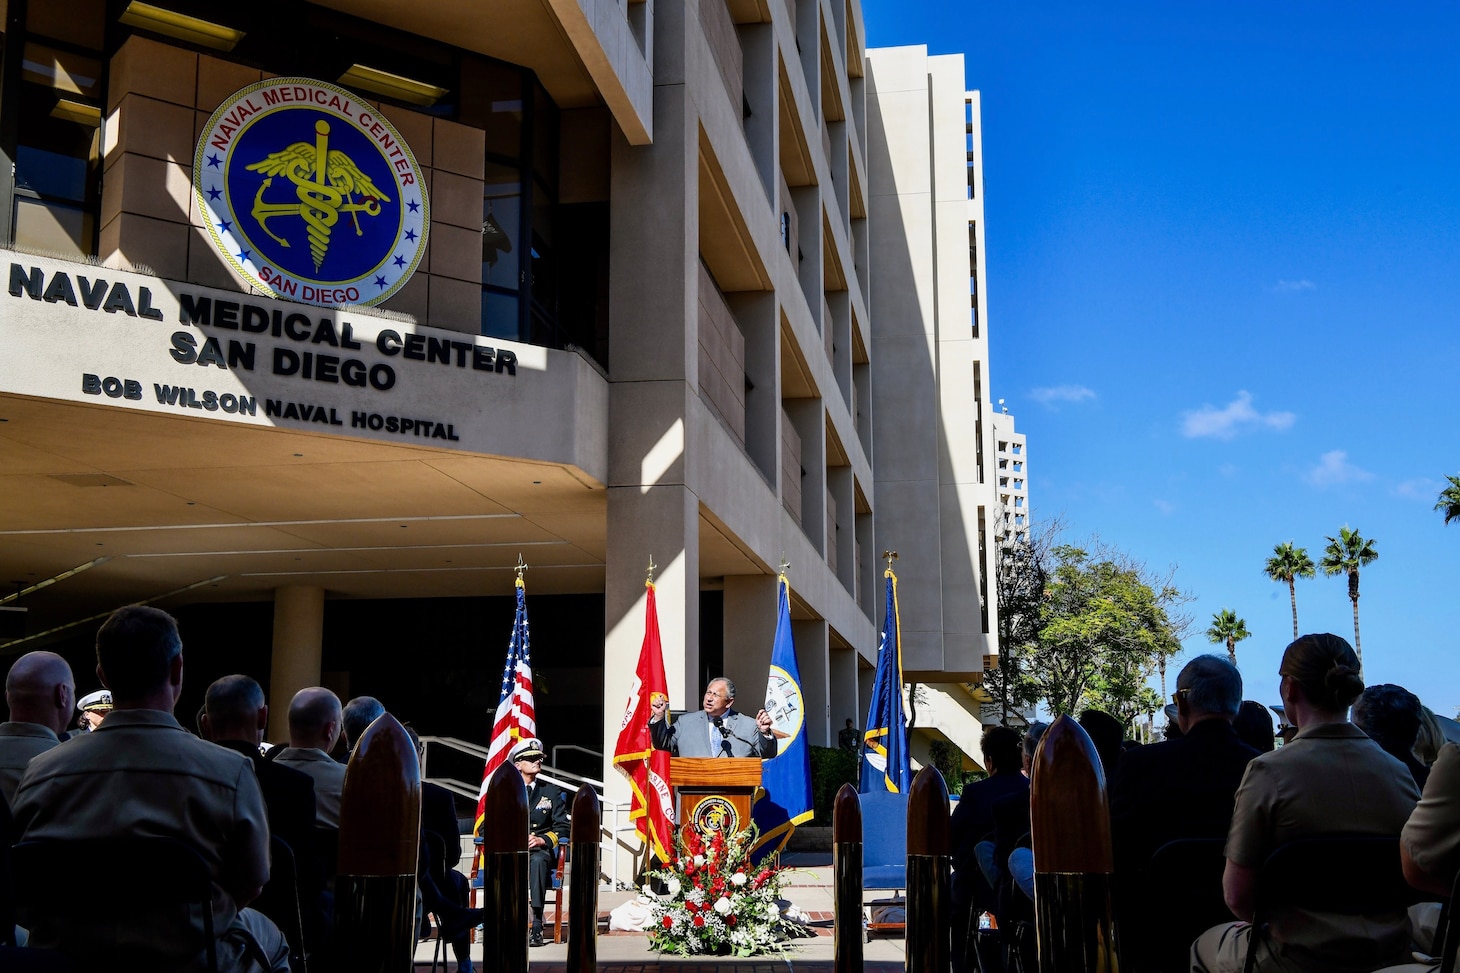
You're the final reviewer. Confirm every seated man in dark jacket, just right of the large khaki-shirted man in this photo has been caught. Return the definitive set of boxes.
[199,675,330,948]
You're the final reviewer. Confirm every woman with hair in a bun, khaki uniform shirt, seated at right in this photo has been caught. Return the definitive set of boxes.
[1191,634,1419,973]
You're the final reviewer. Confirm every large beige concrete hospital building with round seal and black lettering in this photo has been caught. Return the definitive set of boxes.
[0,0,997,799]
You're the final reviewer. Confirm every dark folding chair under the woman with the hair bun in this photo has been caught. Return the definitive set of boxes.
[1244,834,1422,973]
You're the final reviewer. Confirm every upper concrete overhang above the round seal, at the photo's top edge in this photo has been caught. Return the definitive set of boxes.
[328,0,654,145]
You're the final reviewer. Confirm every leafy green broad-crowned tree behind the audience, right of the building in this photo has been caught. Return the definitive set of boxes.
[1028,542,1190,722]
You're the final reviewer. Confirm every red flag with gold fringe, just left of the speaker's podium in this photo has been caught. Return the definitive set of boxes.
[613,572,675,862]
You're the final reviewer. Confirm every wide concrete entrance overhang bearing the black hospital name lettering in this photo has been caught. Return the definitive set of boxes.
[0,251,607,653]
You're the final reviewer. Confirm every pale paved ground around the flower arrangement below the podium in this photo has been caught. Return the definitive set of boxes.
[416,853,907,973]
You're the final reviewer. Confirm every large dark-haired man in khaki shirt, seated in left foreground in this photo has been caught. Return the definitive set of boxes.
[15,605,289,970]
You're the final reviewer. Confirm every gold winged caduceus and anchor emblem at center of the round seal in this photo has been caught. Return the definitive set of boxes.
[248,120,390,272]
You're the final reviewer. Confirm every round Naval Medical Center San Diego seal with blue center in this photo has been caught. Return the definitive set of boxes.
[193,77,431,305]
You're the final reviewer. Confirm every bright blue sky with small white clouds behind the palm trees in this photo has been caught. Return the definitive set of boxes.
[864,0,1460,716]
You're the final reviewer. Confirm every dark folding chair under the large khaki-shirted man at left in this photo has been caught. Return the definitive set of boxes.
[12,837,218,973]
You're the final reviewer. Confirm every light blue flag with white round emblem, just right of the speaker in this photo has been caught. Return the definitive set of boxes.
[750,574,816,861]
